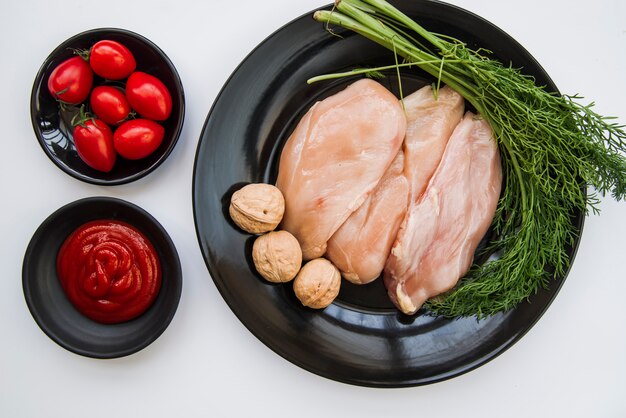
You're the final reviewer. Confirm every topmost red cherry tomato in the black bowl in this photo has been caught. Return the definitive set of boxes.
[89,40,137,80]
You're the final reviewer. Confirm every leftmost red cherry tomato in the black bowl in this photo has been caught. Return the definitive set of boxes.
[48,56,93,104]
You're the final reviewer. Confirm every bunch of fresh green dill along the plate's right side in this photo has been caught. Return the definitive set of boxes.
[314,0,626,317]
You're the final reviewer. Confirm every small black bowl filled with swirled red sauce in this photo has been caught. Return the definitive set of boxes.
[22,197,182,358]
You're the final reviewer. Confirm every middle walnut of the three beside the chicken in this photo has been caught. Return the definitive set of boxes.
[252,231,302,283]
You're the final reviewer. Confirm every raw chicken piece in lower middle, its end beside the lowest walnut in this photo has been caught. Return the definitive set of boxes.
[326,151,409,284]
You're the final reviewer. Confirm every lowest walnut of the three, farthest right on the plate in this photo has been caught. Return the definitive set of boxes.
[293,258,341,309]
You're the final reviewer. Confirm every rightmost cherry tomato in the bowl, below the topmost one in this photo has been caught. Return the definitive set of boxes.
[126,71,172,120]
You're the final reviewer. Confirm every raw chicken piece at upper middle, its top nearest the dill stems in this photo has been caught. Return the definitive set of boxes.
[404,85,464,202]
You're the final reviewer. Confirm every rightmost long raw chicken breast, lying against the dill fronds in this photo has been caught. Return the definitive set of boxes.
[384,112,502,314]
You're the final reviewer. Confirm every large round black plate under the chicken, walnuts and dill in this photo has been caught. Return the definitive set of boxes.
[193,0,583,387]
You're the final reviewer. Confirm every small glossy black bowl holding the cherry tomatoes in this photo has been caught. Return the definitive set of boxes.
[30,28,185,185]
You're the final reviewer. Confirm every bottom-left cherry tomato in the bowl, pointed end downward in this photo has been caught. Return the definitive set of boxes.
[74,119,117,172]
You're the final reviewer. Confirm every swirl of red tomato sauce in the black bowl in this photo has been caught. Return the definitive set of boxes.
[57,220,161,324]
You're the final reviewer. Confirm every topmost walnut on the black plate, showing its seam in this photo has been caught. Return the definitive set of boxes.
[228,183,285,234]
